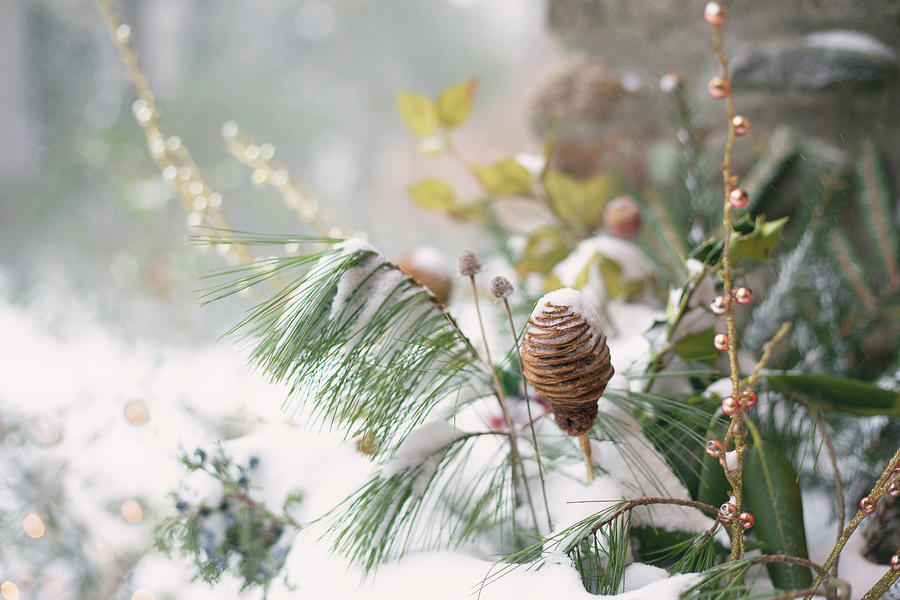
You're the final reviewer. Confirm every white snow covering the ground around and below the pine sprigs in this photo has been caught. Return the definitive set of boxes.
[0,288,708,600]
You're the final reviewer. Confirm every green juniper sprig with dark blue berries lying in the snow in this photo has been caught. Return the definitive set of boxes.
[155,446,302,591]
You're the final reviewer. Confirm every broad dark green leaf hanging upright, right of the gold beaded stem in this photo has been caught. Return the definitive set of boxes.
[744,440,812,590]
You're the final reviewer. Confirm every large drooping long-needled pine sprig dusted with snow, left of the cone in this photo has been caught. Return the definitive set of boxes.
[205,236,488,451]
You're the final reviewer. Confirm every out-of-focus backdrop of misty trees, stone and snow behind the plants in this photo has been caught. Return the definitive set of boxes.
[0,0,900,600]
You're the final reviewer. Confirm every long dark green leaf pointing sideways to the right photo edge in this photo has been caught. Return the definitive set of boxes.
[766,375,900,417]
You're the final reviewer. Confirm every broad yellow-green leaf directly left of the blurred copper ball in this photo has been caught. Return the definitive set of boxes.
[543,171,617,230]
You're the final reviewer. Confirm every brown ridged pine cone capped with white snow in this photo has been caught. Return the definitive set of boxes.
[522,288,614,436]
